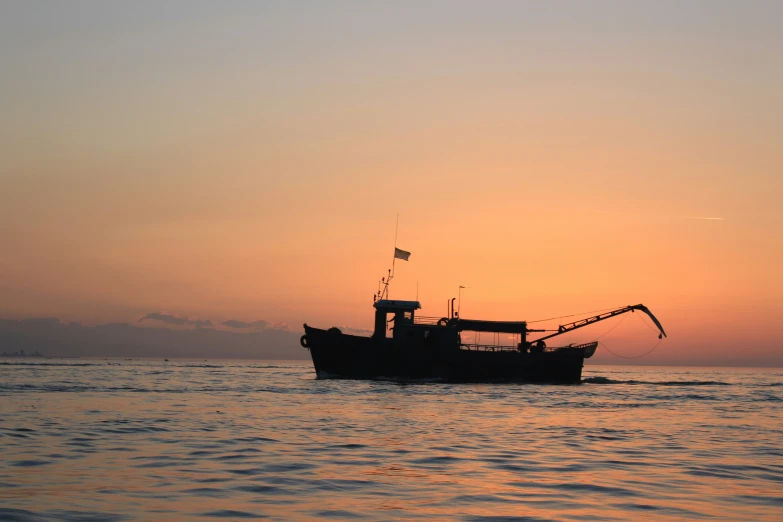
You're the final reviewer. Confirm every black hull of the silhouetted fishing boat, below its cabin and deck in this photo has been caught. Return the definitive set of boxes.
[303,325,595,384]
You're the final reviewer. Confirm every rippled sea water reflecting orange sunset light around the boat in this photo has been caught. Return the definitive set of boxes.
[0,358,783,521]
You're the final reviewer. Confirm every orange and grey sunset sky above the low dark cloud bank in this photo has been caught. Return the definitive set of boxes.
[0,1,783,365]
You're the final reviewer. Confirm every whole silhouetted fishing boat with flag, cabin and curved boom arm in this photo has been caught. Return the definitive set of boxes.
[300,247,666,384]
